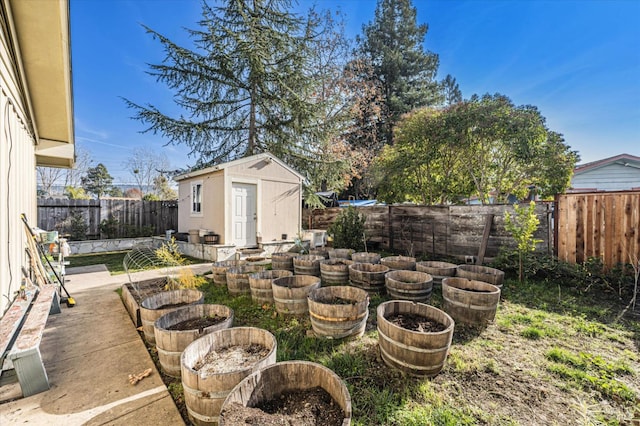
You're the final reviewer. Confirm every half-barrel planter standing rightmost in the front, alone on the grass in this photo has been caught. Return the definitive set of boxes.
[377,300,455,377]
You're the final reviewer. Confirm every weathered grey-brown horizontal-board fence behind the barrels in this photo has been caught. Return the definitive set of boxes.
[303,203,553,261]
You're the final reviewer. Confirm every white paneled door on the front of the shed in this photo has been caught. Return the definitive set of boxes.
[232,183,257,247]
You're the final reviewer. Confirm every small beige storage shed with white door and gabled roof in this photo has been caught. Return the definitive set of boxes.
[174,153,303,248]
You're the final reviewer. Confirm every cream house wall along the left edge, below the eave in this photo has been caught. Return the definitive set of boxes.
[0,21,36,316]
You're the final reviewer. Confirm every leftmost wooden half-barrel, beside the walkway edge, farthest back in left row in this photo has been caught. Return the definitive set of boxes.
[140,290,204,345]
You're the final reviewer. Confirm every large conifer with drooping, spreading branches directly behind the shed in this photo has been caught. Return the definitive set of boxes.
[126,0,315,166]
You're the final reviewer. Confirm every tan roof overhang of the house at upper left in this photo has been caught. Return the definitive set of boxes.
[7,0,75,168]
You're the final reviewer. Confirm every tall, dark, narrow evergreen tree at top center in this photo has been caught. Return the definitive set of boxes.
[358,0,442,143]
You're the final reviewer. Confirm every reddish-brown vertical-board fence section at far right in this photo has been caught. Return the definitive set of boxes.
[556,191,640,268]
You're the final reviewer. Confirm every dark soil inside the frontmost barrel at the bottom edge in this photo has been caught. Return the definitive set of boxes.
[224,387,344,426]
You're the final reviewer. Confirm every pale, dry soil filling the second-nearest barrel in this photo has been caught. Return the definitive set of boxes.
[193,343,269,375]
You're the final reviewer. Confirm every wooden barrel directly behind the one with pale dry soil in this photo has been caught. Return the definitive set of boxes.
[154,304,233,377]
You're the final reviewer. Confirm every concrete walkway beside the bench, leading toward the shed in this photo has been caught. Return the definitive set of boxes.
[0,264,211,426]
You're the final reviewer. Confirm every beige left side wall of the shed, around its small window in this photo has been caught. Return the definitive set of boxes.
[177,171,225,240]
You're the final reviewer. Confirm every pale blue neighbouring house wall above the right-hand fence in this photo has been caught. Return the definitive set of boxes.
[571,163,640,191]
